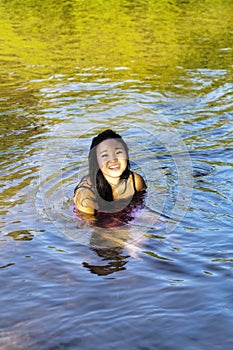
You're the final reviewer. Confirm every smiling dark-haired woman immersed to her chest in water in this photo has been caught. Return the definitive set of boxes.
[73,130,146,215]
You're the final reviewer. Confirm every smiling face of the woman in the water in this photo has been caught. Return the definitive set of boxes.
[96,139,127,182]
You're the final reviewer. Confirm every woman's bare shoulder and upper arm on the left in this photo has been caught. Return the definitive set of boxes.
[73,179,97,214]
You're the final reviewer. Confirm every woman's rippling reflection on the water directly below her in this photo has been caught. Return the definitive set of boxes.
[79,193,145,276]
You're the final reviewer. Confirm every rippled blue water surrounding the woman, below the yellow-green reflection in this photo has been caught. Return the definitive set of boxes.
[1,72,233,349]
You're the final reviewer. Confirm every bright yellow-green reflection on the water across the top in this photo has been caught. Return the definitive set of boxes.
[0,0,233,86]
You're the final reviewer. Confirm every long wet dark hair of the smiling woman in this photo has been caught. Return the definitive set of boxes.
[88,129,130,202]
